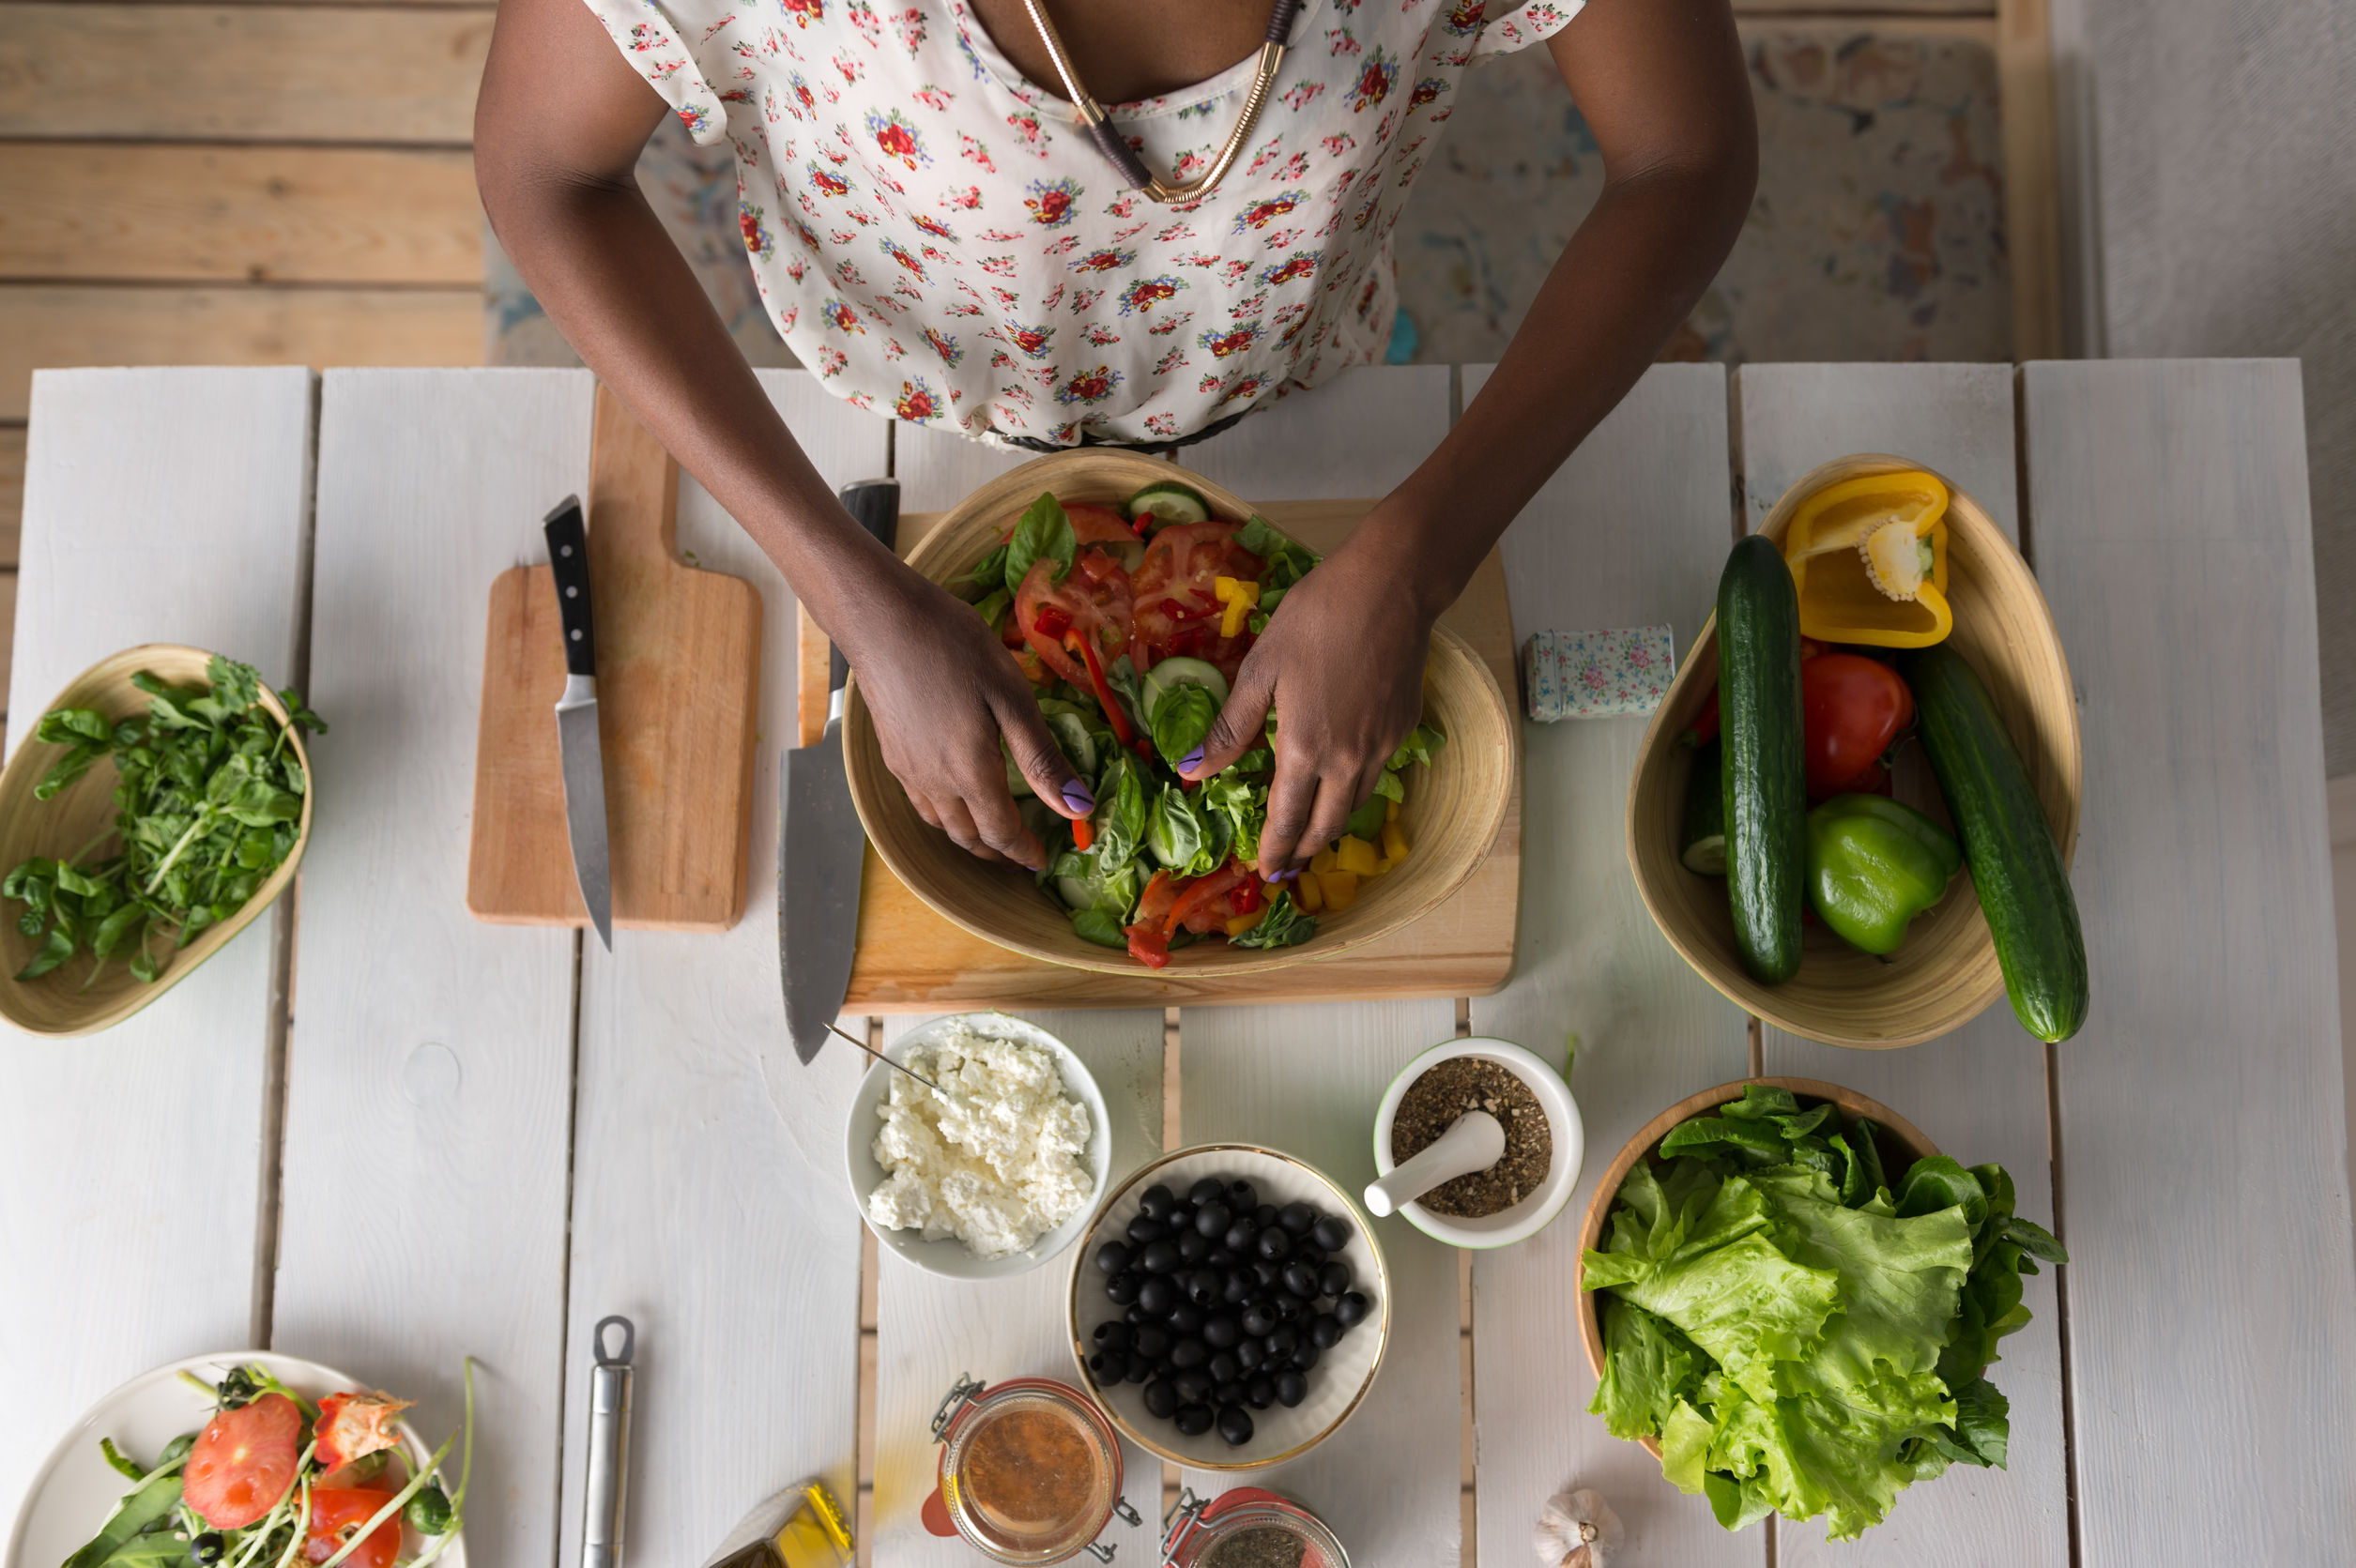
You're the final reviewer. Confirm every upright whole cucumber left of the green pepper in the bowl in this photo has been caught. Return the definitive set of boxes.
[1718,535,1807,984]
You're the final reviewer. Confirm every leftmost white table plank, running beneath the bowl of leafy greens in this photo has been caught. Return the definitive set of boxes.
[0,370,311,1532]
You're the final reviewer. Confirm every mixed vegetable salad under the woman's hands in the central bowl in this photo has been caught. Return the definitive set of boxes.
[964,482,1442,970]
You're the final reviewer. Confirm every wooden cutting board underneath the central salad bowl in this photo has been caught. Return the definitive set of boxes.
[796,499,1522,1012]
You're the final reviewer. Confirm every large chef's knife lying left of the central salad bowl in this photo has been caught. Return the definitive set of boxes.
[777,480,900,1062]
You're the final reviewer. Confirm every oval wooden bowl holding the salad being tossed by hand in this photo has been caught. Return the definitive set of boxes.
[844,449,1517,980]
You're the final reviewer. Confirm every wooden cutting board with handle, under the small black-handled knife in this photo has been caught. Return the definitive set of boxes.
[467,386,768,930]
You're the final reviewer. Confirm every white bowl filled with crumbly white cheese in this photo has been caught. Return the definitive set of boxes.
[844,1012,1112,1278]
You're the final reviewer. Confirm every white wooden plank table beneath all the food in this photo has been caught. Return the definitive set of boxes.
[0,360,2356,1568]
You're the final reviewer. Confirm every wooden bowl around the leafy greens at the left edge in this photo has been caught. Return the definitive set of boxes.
[0,643,318,1036]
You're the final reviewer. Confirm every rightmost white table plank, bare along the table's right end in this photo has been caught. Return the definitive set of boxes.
[2022,360,2356,1563]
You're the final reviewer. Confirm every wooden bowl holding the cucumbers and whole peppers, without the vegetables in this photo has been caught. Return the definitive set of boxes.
[1628,454,2083,1050]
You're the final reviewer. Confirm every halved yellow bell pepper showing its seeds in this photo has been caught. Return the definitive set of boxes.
[1783,471,1955,647]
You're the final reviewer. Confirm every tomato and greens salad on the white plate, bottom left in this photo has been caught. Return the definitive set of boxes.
[66,1363,474,1568]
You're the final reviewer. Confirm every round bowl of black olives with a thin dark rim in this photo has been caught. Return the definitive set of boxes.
[1070,1144,1390,1469]
